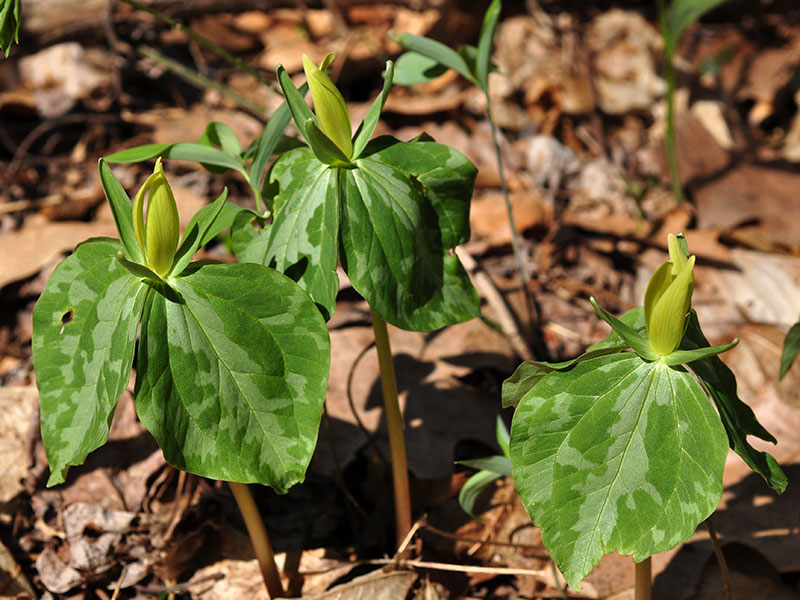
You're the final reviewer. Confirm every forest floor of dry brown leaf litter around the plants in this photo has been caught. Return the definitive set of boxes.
[0,0,800,600]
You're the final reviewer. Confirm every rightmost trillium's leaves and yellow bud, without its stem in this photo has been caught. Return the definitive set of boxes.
[503,235,787,587]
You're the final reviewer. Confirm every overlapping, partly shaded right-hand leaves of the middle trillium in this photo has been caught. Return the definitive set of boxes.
[340,138,480,331]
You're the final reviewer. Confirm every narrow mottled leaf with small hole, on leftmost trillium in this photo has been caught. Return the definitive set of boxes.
[33,239,148,485]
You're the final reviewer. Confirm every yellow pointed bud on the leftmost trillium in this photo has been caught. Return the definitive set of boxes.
[133,158,180,277]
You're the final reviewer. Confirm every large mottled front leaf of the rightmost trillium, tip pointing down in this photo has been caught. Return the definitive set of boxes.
[511,353,727,587]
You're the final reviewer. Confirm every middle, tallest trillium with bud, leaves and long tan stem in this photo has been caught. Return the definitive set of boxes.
[108,54,480,539]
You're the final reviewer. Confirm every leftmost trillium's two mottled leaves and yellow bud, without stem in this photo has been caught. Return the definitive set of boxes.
[33,160,330,492]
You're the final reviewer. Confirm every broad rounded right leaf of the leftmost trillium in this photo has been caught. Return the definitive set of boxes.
[136,264,330,493]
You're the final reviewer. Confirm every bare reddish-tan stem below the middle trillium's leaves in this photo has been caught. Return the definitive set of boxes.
[372,311,411,544]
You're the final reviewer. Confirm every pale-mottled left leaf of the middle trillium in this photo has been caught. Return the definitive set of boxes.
[260,147,339,319]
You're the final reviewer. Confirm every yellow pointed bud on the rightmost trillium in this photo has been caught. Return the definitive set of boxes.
[644,234,695,356]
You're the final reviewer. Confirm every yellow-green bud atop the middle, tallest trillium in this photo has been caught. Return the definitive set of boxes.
[303,52,353,159]
